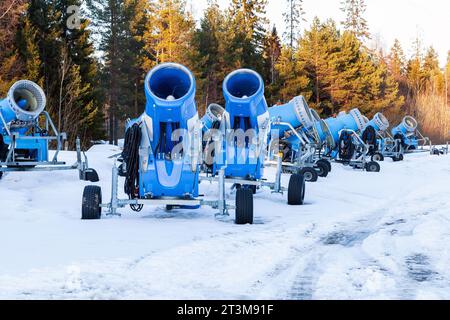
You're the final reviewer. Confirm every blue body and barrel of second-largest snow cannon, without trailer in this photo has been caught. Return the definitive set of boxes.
[223,69,270,180]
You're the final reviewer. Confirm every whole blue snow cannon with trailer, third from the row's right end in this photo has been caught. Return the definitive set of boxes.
[319,109,380,172]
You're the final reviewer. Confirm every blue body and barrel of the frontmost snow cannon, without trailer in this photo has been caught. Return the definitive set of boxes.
[135,63,201,198]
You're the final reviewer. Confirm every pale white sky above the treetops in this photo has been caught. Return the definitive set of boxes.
[190,0,450,66]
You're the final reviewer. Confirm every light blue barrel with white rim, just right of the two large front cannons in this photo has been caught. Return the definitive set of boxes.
[269,96,314,138]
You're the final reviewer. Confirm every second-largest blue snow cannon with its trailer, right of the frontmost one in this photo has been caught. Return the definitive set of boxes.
[201,69,305,214]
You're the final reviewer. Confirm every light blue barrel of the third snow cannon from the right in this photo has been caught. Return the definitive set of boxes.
[320,109,367,149]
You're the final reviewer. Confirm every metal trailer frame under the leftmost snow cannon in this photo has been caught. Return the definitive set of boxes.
[0,111,98,182]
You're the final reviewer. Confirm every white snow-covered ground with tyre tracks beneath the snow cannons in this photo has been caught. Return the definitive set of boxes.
[0,145,450,299]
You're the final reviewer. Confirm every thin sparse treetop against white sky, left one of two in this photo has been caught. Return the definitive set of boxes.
[283,0,306,48]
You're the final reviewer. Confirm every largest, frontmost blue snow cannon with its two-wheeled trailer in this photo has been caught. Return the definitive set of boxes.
[82,63,248,223]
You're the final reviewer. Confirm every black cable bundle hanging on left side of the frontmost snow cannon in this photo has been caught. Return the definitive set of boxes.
[122,123,144,212]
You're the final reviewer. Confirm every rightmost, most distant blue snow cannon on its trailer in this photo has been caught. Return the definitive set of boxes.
[391,116,431,153]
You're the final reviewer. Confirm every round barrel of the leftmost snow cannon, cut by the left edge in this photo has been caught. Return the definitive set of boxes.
[0,80,46,132]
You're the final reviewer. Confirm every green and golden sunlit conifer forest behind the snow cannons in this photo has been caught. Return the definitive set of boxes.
[0,0,450,147]
